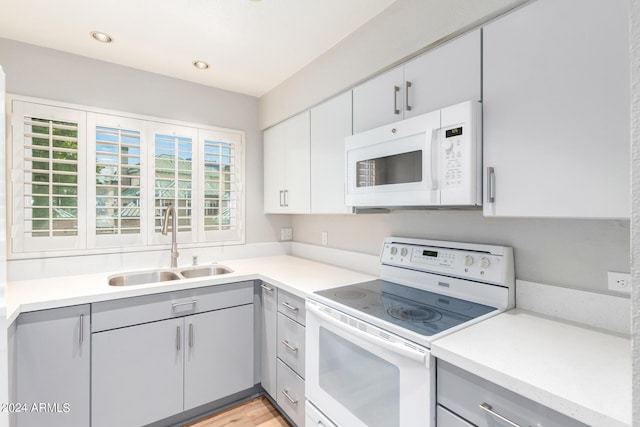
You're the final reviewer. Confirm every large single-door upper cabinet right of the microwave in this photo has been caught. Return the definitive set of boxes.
[483,0,630,218]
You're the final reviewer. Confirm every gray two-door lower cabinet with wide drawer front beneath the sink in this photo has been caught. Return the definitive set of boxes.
[91,282,254,427]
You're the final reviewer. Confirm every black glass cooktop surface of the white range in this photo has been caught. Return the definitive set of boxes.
[316,280,497,336]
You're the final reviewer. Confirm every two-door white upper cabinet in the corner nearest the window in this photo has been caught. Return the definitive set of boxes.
[264,111,311,214]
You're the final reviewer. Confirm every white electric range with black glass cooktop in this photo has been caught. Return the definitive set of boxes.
[305,237,515,427]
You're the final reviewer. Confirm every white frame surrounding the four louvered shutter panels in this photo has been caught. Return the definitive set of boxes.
[6,94,246,259]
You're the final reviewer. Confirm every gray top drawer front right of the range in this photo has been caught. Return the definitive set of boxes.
[436,360,587,427]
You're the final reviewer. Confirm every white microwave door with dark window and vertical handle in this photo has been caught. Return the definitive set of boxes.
[345,111,440,207]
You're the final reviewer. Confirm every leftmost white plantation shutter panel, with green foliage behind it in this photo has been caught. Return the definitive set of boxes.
[11,101,86,252]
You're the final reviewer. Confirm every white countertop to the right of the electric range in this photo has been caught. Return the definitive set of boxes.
[431,309,631,427]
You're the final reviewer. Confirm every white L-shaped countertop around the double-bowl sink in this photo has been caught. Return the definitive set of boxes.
[7,255,374,324]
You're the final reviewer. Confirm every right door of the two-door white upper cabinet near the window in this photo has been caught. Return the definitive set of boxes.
[283,111,311,213]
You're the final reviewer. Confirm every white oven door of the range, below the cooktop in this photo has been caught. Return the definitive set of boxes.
[306,300,435,427]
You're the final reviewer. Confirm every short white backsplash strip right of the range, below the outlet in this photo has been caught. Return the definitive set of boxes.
[516,280,631,335]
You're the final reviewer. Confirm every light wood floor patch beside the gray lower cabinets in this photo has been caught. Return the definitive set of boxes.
[183,396,291,427]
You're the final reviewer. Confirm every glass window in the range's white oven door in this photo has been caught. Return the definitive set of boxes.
[318,327,400,427]
